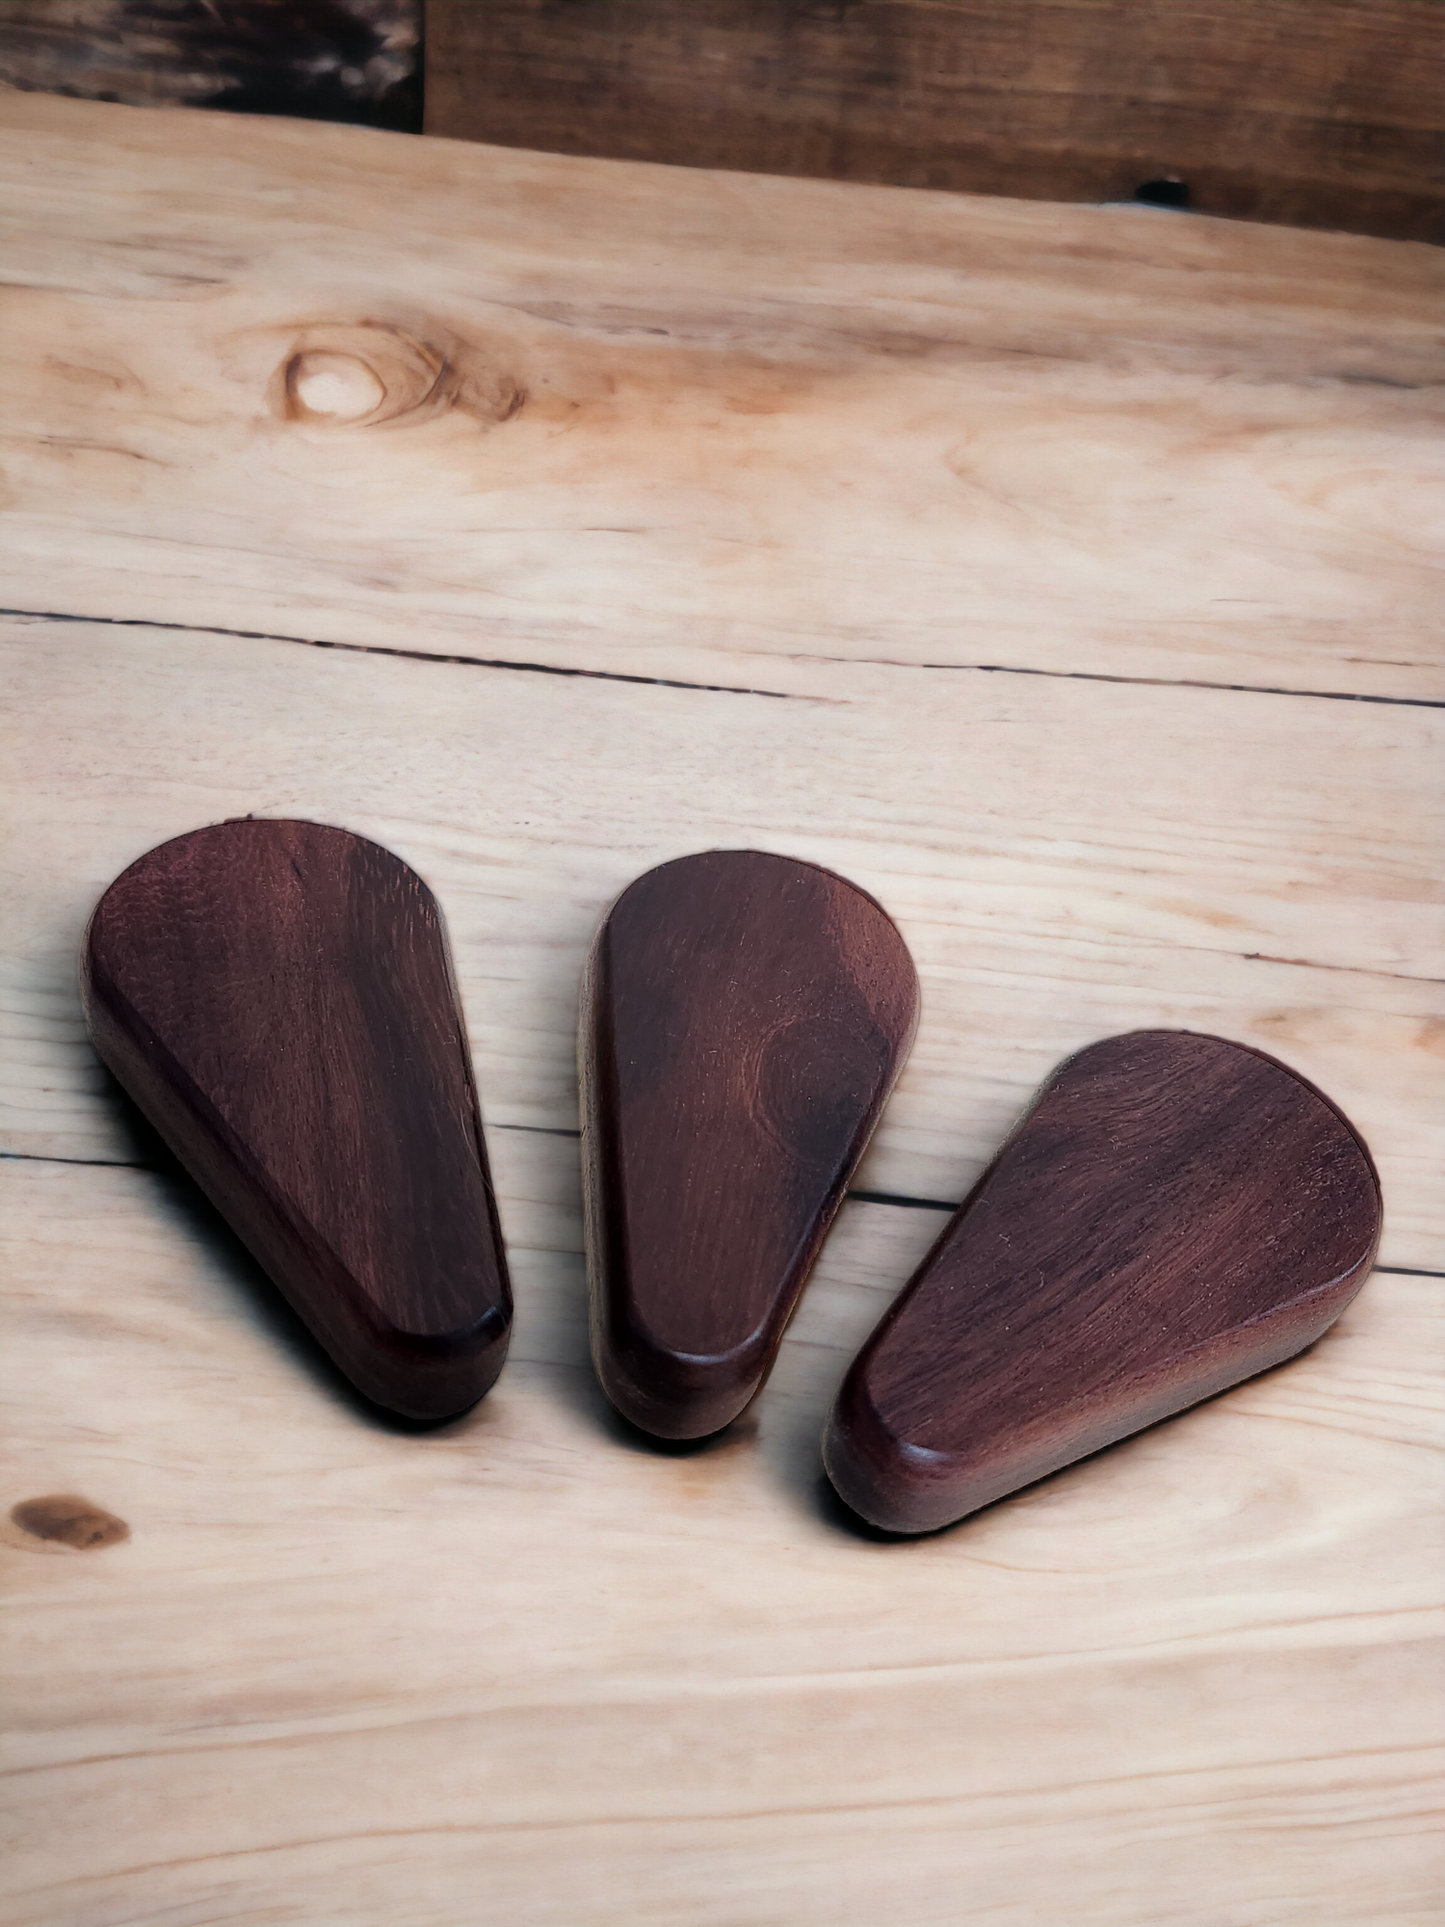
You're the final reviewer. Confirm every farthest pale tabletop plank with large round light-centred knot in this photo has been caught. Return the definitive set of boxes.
[0,94,1445,700]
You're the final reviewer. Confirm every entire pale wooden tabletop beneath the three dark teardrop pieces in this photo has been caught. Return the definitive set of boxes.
[0,98,1445,1927]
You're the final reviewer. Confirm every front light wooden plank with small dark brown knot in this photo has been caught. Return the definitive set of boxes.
[0,1133,1445,1927]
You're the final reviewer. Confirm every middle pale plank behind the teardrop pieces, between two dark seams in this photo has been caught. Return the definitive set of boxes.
[0,620,1445,1270]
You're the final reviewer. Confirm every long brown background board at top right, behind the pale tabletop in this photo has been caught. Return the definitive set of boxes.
[426,0,1445,241]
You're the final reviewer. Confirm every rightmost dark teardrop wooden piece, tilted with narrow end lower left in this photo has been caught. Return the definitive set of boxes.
[823,1031,1379,1532]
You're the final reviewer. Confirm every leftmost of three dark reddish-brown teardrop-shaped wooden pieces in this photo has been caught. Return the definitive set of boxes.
[81,817,512,1420]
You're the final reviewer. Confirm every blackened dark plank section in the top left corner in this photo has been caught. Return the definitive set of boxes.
[0,0,422,133]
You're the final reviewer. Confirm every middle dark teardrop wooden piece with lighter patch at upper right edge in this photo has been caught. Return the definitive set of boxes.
[578,850,917,1439]
